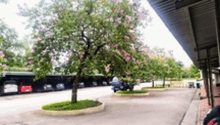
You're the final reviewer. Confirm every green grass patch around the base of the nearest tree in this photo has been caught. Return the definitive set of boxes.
[42,100,101,111]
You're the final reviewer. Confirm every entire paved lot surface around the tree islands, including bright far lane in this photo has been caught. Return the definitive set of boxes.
[0,83,196,125]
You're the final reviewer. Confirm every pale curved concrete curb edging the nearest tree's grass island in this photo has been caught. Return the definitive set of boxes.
[41,103,105,116]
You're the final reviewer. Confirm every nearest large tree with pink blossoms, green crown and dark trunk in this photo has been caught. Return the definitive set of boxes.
[19,0,148,103]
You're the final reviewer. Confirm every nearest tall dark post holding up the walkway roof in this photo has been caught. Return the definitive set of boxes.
[206,49,214,108]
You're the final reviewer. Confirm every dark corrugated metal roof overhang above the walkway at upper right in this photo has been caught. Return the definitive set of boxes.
[149,0,219,68]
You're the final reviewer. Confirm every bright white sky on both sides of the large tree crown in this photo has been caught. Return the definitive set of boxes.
[0,0,192,67]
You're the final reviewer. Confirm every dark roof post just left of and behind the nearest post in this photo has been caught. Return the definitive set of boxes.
[202,65,211,105]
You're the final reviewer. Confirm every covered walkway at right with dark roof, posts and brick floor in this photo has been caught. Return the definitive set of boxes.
[149,0,220,121]
